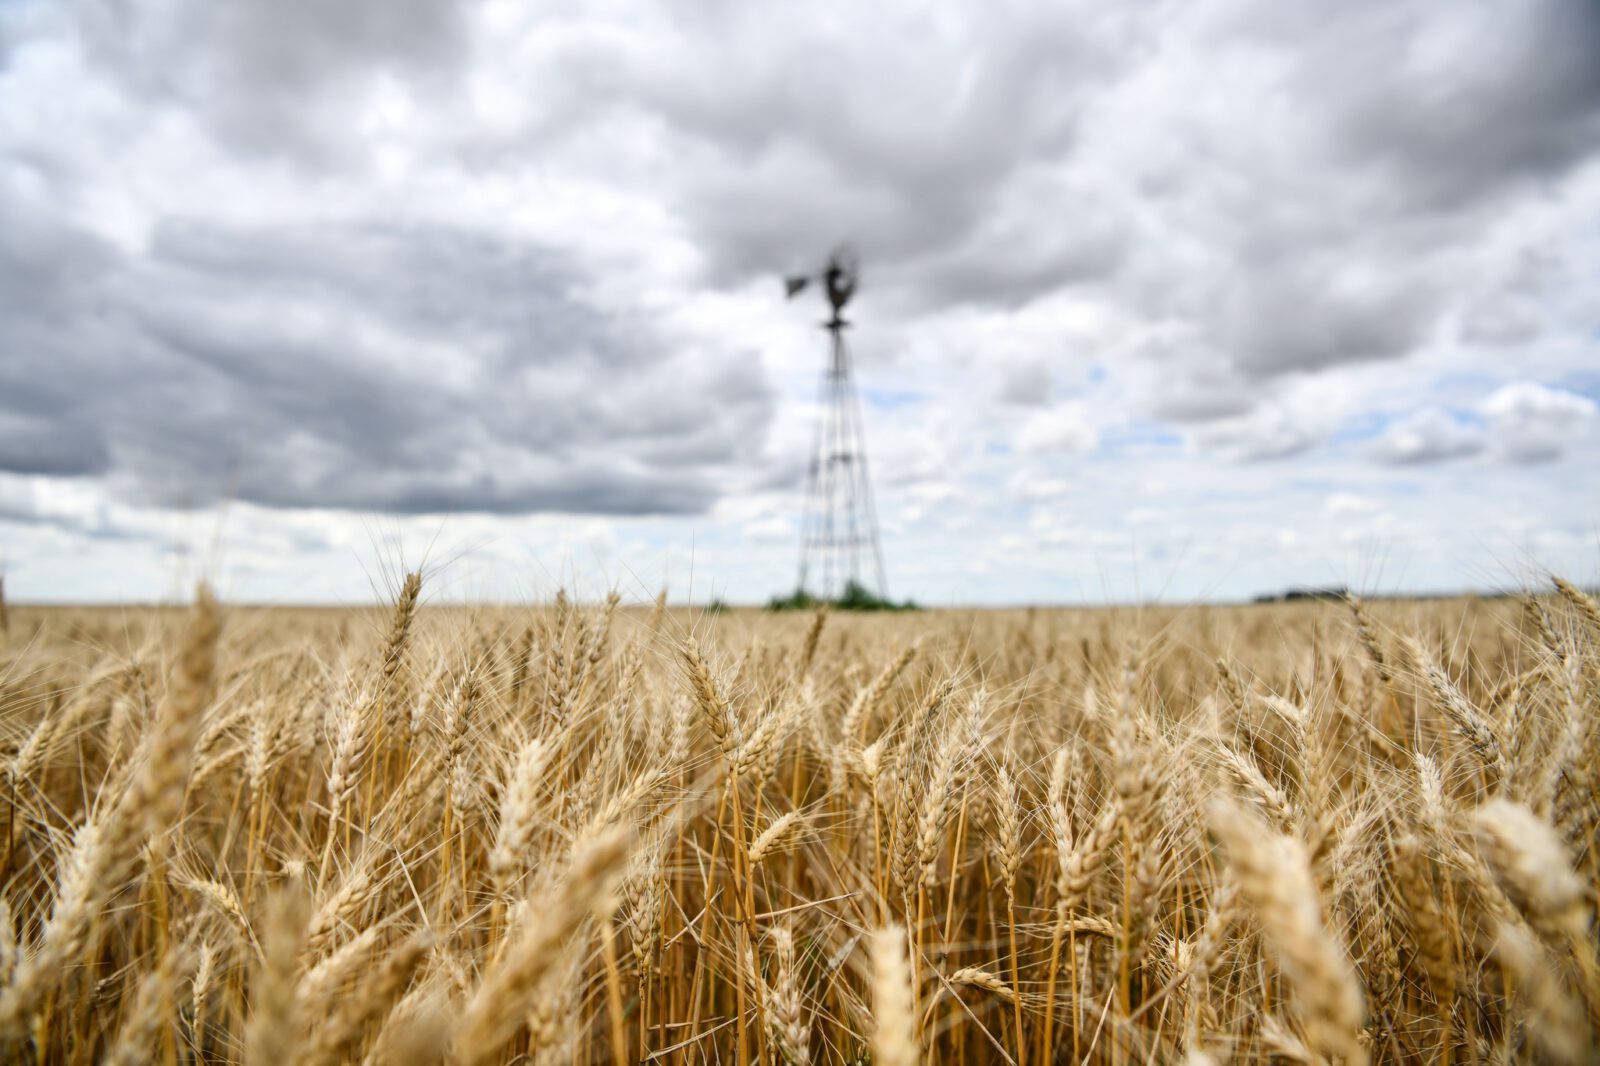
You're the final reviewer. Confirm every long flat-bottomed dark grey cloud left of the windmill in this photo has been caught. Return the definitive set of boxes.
[0,198,771,514]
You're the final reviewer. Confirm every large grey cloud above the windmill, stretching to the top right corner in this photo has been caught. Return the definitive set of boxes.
[540,0,1600,358]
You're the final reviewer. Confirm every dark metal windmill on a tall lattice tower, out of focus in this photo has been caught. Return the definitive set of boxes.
[787,248,888,600]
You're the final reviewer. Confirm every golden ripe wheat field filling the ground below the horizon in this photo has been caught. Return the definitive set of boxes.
[0,578,1600,1066]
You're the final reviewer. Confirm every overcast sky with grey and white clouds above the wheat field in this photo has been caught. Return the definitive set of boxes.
[0,0,1600,605]
